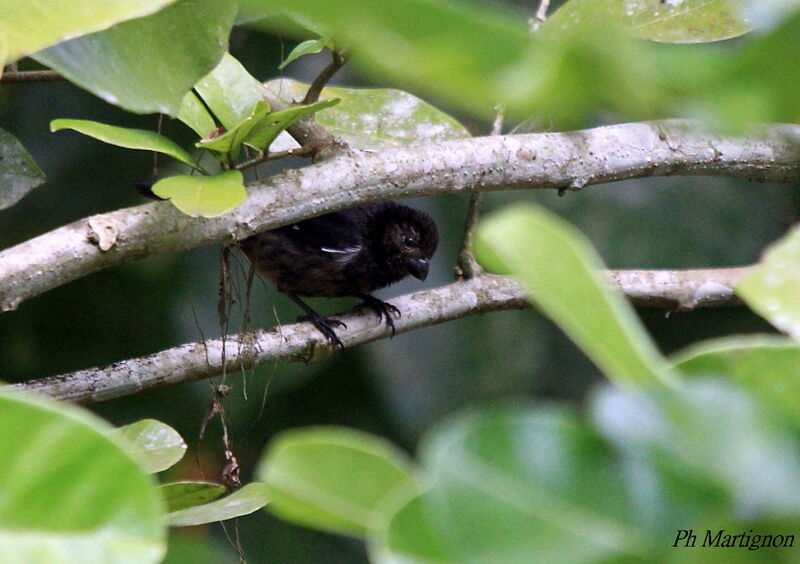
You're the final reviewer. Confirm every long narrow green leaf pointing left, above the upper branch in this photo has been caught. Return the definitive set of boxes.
[50,119,198,169]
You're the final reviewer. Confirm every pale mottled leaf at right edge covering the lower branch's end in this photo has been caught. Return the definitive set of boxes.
[736,227,800,340]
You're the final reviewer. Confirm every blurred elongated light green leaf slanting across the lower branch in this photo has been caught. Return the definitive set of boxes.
[475,205,671,386]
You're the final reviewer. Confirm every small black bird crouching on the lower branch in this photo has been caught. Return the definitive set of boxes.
[240,198,439,348]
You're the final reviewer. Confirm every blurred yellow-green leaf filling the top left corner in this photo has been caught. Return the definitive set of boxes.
[0,0,175,67]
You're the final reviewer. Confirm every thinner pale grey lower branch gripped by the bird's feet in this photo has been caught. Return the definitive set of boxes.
[11,267,748,403]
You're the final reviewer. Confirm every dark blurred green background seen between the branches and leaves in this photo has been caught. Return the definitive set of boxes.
[0,2,800,563]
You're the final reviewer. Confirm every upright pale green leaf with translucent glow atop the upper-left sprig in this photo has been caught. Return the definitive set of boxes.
[195,53,269,131]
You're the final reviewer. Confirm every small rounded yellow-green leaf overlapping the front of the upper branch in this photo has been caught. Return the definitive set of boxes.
[152,170,247,217]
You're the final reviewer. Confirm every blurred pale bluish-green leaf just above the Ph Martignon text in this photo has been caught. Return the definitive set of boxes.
[593,379,800,528]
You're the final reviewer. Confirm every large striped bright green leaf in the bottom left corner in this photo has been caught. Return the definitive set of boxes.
[0,390,166,564]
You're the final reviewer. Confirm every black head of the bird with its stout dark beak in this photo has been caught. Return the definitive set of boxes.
[381,202,439,280]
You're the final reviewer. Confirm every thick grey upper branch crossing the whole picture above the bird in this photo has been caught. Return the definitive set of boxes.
[0,121,800,310]
